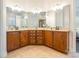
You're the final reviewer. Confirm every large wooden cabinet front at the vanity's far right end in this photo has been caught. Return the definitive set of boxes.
[54,32,68,53]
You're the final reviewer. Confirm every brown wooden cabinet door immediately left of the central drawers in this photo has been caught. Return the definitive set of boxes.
[20,31,29,46]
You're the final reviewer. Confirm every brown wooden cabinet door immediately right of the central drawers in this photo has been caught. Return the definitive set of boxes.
[45,31,54,47]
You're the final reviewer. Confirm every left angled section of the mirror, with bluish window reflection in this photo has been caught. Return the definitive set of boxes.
[6,7,28,29]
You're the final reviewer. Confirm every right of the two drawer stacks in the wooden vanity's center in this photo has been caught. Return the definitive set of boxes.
[36,30,44,44]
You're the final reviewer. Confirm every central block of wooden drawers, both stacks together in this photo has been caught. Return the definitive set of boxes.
[29,30,44,45]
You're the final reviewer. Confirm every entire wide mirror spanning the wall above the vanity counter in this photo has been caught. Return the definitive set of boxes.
[6,5,70,29]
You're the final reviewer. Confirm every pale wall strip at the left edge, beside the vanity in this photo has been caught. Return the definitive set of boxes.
[0,0,7,58]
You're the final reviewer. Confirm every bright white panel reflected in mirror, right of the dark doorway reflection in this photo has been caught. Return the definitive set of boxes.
[46,11,55,28]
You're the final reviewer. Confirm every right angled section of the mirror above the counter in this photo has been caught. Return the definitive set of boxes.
[46,5,70,29]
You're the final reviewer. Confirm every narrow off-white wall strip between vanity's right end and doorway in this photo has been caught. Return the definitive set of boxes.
[69,0,76,56]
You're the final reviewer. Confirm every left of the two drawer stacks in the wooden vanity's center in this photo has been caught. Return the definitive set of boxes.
[28,30,36,45]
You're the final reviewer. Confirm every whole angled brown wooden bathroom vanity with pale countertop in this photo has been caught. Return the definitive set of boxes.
[7,28,69,53]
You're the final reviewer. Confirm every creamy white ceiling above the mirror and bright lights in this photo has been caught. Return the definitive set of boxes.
[5,0,71,11]
